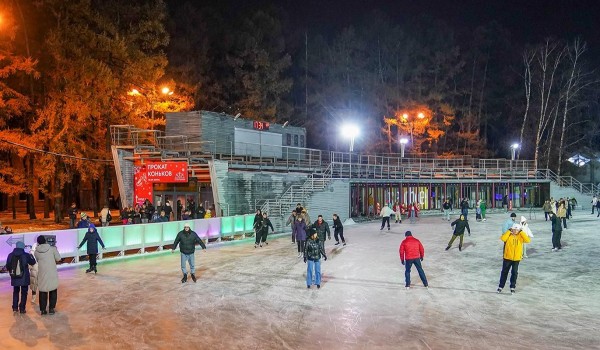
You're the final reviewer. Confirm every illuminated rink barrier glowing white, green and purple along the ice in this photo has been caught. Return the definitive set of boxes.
[0,214,255,266]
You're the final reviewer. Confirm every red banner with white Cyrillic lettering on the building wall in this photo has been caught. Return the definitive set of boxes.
[133,162,188,204]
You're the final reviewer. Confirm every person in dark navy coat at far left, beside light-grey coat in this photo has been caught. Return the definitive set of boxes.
[6,241,36,314]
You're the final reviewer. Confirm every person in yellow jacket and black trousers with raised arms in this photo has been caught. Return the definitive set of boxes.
[498,224,531,294]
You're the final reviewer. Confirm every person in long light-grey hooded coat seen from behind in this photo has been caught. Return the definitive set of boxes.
[35,235,61,315]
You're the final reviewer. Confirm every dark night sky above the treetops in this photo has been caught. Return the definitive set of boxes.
[210,0,600,52]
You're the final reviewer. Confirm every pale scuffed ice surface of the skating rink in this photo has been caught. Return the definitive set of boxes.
[0,210,600,350]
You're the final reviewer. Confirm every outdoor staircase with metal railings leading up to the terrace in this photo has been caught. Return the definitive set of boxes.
[260,164,332,221]
